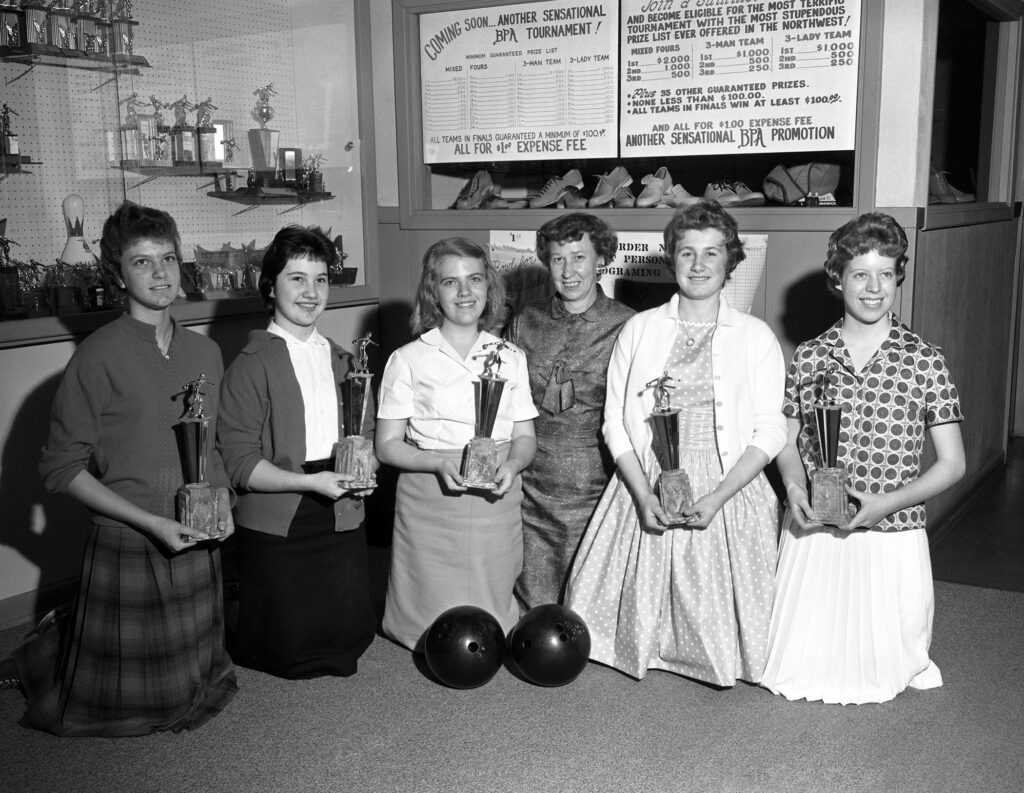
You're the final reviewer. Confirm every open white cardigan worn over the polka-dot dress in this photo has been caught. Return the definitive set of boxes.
[602,294,786,473]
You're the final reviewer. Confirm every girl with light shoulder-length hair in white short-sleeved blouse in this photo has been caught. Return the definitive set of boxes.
[377,237,537,652]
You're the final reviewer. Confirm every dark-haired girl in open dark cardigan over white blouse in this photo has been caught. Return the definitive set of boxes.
[218,225,377,678]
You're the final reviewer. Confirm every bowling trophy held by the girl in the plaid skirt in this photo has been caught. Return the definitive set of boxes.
[174,374,220,540]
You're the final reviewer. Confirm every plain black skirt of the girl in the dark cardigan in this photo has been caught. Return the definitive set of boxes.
[231,495,377,679]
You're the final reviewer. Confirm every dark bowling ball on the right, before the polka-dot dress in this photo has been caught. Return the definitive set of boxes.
[509,603,590,685]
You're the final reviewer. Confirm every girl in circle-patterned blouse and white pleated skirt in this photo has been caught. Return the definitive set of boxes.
[762,213,965,705]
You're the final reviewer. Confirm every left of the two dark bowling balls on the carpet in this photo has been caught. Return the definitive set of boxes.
[423,606,505,688]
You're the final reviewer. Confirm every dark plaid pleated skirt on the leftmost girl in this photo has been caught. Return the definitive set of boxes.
[15,525,238,737]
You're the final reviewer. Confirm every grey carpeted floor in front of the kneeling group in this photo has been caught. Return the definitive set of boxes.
[0,583,1024,793]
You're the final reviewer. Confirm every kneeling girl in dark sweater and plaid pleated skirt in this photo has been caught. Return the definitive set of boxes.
[15,204,237,737]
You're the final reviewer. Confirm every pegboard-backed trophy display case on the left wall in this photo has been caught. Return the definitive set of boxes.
[0,0,377,347]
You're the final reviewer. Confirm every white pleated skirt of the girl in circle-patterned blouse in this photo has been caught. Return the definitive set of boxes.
[761,514,942,705]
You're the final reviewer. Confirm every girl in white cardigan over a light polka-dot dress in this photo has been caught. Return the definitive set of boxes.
[567,201,785,686]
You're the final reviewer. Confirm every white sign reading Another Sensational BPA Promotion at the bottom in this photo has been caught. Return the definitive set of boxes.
[620,0,860,157]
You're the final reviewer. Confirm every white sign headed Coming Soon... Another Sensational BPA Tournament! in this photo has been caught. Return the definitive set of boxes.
[420,0,620,164]
